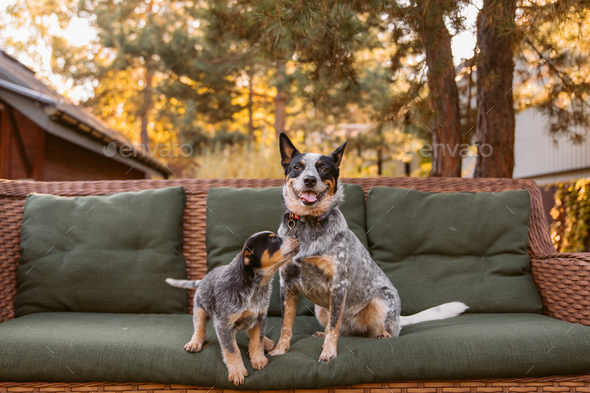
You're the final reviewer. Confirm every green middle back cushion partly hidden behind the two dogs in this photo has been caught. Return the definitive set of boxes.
[206,184,368,315]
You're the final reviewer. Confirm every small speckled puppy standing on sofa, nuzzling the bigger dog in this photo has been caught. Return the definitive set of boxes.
[166,232,299,386]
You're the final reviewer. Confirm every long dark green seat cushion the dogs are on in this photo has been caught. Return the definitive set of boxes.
[0,313,590,390]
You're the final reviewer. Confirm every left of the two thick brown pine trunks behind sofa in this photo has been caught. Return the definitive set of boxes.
[419,13,462,177]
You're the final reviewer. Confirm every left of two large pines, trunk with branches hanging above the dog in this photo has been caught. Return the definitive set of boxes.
[256,0,462,176]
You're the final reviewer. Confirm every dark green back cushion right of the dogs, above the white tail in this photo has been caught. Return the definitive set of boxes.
[367,187,543,315]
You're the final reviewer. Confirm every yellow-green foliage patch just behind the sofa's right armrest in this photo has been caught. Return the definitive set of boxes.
[551,179,590,252]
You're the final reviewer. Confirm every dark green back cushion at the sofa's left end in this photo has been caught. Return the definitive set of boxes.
[15,187,187,316]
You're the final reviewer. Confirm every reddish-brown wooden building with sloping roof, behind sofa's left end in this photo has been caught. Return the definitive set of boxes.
[0,50,170,181]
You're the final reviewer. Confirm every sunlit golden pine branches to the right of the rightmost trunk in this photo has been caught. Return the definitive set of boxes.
[513,0,590,143]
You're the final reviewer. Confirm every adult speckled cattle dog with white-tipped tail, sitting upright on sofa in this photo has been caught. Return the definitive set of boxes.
[269,133,467,362]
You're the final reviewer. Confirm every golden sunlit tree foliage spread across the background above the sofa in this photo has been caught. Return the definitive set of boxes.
[0,0,590,175]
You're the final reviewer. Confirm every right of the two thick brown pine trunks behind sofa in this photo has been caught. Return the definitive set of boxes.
[475,0,516,177]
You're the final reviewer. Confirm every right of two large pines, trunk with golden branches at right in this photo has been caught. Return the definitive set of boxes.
[475,0,590,177]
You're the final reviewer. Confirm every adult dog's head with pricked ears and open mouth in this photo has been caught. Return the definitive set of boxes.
[279,133,346,216]
